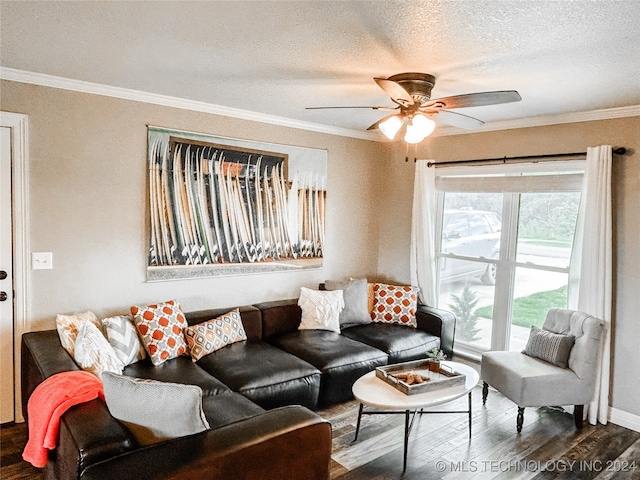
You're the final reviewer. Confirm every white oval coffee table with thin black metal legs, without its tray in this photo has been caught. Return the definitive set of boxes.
[353,361,480,471]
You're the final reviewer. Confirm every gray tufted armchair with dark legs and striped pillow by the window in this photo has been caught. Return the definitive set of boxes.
[480,309,604,433]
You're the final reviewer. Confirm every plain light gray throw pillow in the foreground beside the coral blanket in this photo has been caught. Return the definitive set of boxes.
[102,372,209,445]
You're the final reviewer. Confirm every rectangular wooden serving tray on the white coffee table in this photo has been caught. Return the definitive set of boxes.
[376,360,465,395]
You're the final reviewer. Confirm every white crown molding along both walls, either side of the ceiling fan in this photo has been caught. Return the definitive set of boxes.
[0,67,640,142]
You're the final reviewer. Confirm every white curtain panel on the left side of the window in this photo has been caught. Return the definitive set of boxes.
[410,160,436,306]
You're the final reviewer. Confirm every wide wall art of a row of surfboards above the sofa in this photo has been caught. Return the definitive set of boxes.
[147,126,327,281]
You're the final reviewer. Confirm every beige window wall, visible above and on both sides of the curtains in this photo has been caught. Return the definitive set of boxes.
[378,117,640,415]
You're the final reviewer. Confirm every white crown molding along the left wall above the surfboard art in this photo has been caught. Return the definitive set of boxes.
[0,67,380,141]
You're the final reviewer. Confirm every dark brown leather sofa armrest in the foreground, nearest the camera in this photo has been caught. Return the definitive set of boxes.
[80,406,331,480]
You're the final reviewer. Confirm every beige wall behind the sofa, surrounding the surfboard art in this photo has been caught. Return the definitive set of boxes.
[0,81,388,330]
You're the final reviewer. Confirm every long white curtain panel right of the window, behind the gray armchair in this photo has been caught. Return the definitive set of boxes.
[569,145,613,425]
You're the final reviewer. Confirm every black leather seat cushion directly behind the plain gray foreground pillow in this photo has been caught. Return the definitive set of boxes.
[122,357,230,396]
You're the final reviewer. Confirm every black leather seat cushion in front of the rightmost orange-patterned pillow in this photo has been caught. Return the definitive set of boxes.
[342,322,440,363]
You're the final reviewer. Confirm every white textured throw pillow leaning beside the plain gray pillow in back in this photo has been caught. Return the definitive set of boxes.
[298,287,344,333]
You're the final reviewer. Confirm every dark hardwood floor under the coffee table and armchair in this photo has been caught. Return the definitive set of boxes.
[0,387,640,480]
